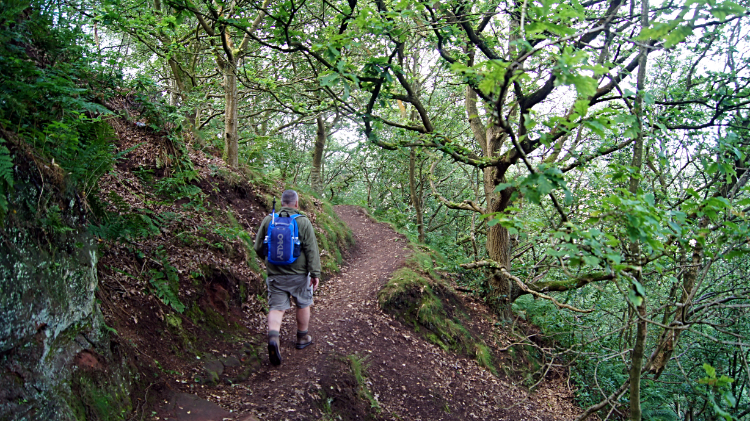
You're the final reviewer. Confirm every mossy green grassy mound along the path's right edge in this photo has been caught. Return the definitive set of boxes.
[378,246,497,374]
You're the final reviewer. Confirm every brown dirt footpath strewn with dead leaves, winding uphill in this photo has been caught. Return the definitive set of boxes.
[154,206,570,421]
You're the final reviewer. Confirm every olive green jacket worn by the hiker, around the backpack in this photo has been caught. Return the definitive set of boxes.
[253,206,320,278]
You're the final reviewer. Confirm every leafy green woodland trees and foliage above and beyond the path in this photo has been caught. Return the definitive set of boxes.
[0,0,750,420]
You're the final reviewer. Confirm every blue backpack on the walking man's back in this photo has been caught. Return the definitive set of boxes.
[263,201,302,266]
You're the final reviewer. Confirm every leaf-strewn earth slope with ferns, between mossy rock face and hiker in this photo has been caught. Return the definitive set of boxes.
[86,97,351,419]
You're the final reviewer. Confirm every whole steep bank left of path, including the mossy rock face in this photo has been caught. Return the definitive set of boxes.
[0,91,351,420]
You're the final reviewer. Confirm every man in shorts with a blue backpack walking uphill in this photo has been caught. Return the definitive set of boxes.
[254,190,320,365]
